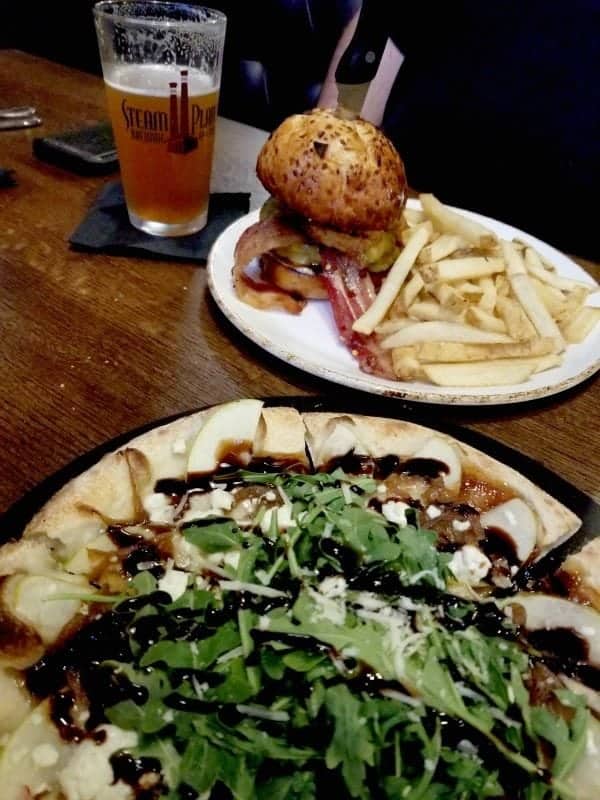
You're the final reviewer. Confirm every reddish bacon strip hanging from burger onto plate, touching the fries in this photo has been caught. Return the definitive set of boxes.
[321,249,395,380]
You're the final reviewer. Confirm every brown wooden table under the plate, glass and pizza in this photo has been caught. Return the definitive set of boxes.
[0,50,600,510]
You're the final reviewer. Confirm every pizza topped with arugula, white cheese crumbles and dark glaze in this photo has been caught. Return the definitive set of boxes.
[0,399,600,800]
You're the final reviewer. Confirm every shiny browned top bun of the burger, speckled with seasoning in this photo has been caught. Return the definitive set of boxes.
[256,108,406,233]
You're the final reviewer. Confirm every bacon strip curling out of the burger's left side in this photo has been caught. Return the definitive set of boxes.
[232,217,306,314]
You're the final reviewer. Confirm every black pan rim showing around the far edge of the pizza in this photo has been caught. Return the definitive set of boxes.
[0,396,600,582]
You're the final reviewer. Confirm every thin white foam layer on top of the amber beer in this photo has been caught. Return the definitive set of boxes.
[104,64,219,97]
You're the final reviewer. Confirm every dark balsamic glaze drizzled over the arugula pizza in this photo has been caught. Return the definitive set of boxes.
[19,451,584,800]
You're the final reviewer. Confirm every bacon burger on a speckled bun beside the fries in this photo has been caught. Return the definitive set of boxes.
[233,109,407,372]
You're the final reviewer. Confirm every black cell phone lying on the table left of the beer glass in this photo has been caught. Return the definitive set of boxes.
[33,122,119,175]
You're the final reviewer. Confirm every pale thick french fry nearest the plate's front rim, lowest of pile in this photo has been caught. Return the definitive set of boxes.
[421,359,535,386]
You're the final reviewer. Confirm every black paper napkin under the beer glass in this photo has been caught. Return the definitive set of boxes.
[69,182,250,261]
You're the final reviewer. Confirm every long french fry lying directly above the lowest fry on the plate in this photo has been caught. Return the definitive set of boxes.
[396,339,560,364]
